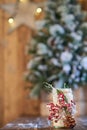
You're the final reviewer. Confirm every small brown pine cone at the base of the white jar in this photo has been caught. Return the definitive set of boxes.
[64,115,76,128]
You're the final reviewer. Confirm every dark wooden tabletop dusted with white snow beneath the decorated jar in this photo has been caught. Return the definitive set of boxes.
[0,117,87,130]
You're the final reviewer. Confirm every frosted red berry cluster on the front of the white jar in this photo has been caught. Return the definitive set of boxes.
[47,93,75,122]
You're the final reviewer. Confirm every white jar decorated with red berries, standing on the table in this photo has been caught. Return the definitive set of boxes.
[52,88,76,128]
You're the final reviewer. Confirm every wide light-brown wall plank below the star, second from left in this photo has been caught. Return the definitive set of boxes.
[4,0,23,123]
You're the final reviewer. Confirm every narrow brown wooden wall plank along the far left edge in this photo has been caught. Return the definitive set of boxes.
[0,0,5,126]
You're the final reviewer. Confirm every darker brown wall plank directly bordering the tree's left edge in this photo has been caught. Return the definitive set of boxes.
[17,26,40,115]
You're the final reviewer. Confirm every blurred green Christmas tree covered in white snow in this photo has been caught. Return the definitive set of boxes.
[26,0,87,95]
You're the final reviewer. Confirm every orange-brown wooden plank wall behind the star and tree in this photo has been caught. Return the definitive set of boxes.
[0,0,87,126]
